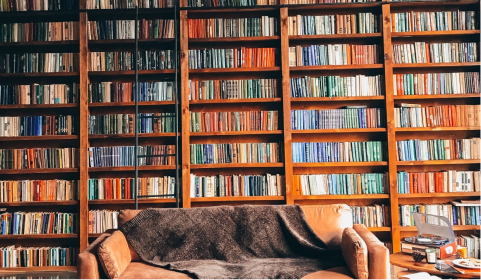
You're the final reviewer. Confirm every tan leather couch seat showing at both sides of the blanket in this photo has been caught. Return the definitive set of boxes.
[119,262,354,279]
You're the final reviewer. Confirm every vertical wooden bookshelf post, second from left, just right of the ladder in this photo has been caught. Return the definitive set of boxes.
[180,10,190,208]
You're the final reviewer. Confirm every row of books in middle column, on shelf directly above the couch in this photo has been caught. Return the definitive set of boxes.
[190,173,285,197]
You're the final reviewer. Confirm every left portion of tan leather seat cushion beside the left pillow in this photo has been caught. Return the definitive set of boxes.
[120,262,193,279]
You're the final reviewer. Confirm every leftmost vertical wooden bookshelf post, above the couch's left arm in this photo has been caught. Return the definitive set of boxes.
[78,8,89,251]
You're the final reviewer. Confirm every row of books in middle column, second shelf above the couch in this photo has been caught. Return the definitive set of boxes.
[190,143,282,164]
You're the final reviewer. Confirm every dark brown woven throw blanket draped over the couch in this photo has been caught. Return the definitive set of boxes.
[121,205,344,279]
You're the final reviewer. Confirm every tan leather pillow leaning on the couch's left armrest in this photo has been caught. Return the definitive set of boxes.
[98,230,131,279]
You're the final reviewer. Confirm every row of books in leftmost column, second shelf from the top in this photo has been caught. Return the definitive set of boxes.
[0,21,79,42]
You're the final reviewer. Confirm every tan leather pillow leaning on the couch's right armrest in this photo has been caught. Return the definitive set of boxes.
[341,228,369,279]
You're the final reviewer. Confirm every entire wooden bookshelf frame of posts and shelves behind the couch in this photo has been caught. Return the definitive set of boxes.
[0,0,481,266]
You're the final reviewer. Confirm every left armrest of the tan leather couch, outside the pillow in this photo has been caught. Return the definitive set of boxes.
[77,233,110,279]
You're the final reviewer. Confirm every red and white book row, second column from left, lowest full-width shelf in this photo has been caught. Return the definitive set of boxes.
[88,176,176,200]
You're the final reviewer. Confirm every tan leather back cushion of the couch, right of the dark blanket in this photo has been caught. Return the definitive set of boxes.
[301,204,352,249]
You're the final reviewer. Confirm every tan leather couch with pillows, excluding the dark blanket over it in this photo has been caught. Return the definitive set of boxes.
[77,204,391,279]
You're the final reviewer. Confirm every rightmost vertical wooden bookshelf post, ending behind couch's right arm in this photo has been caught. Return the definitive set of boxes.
[382,4,401,252]
